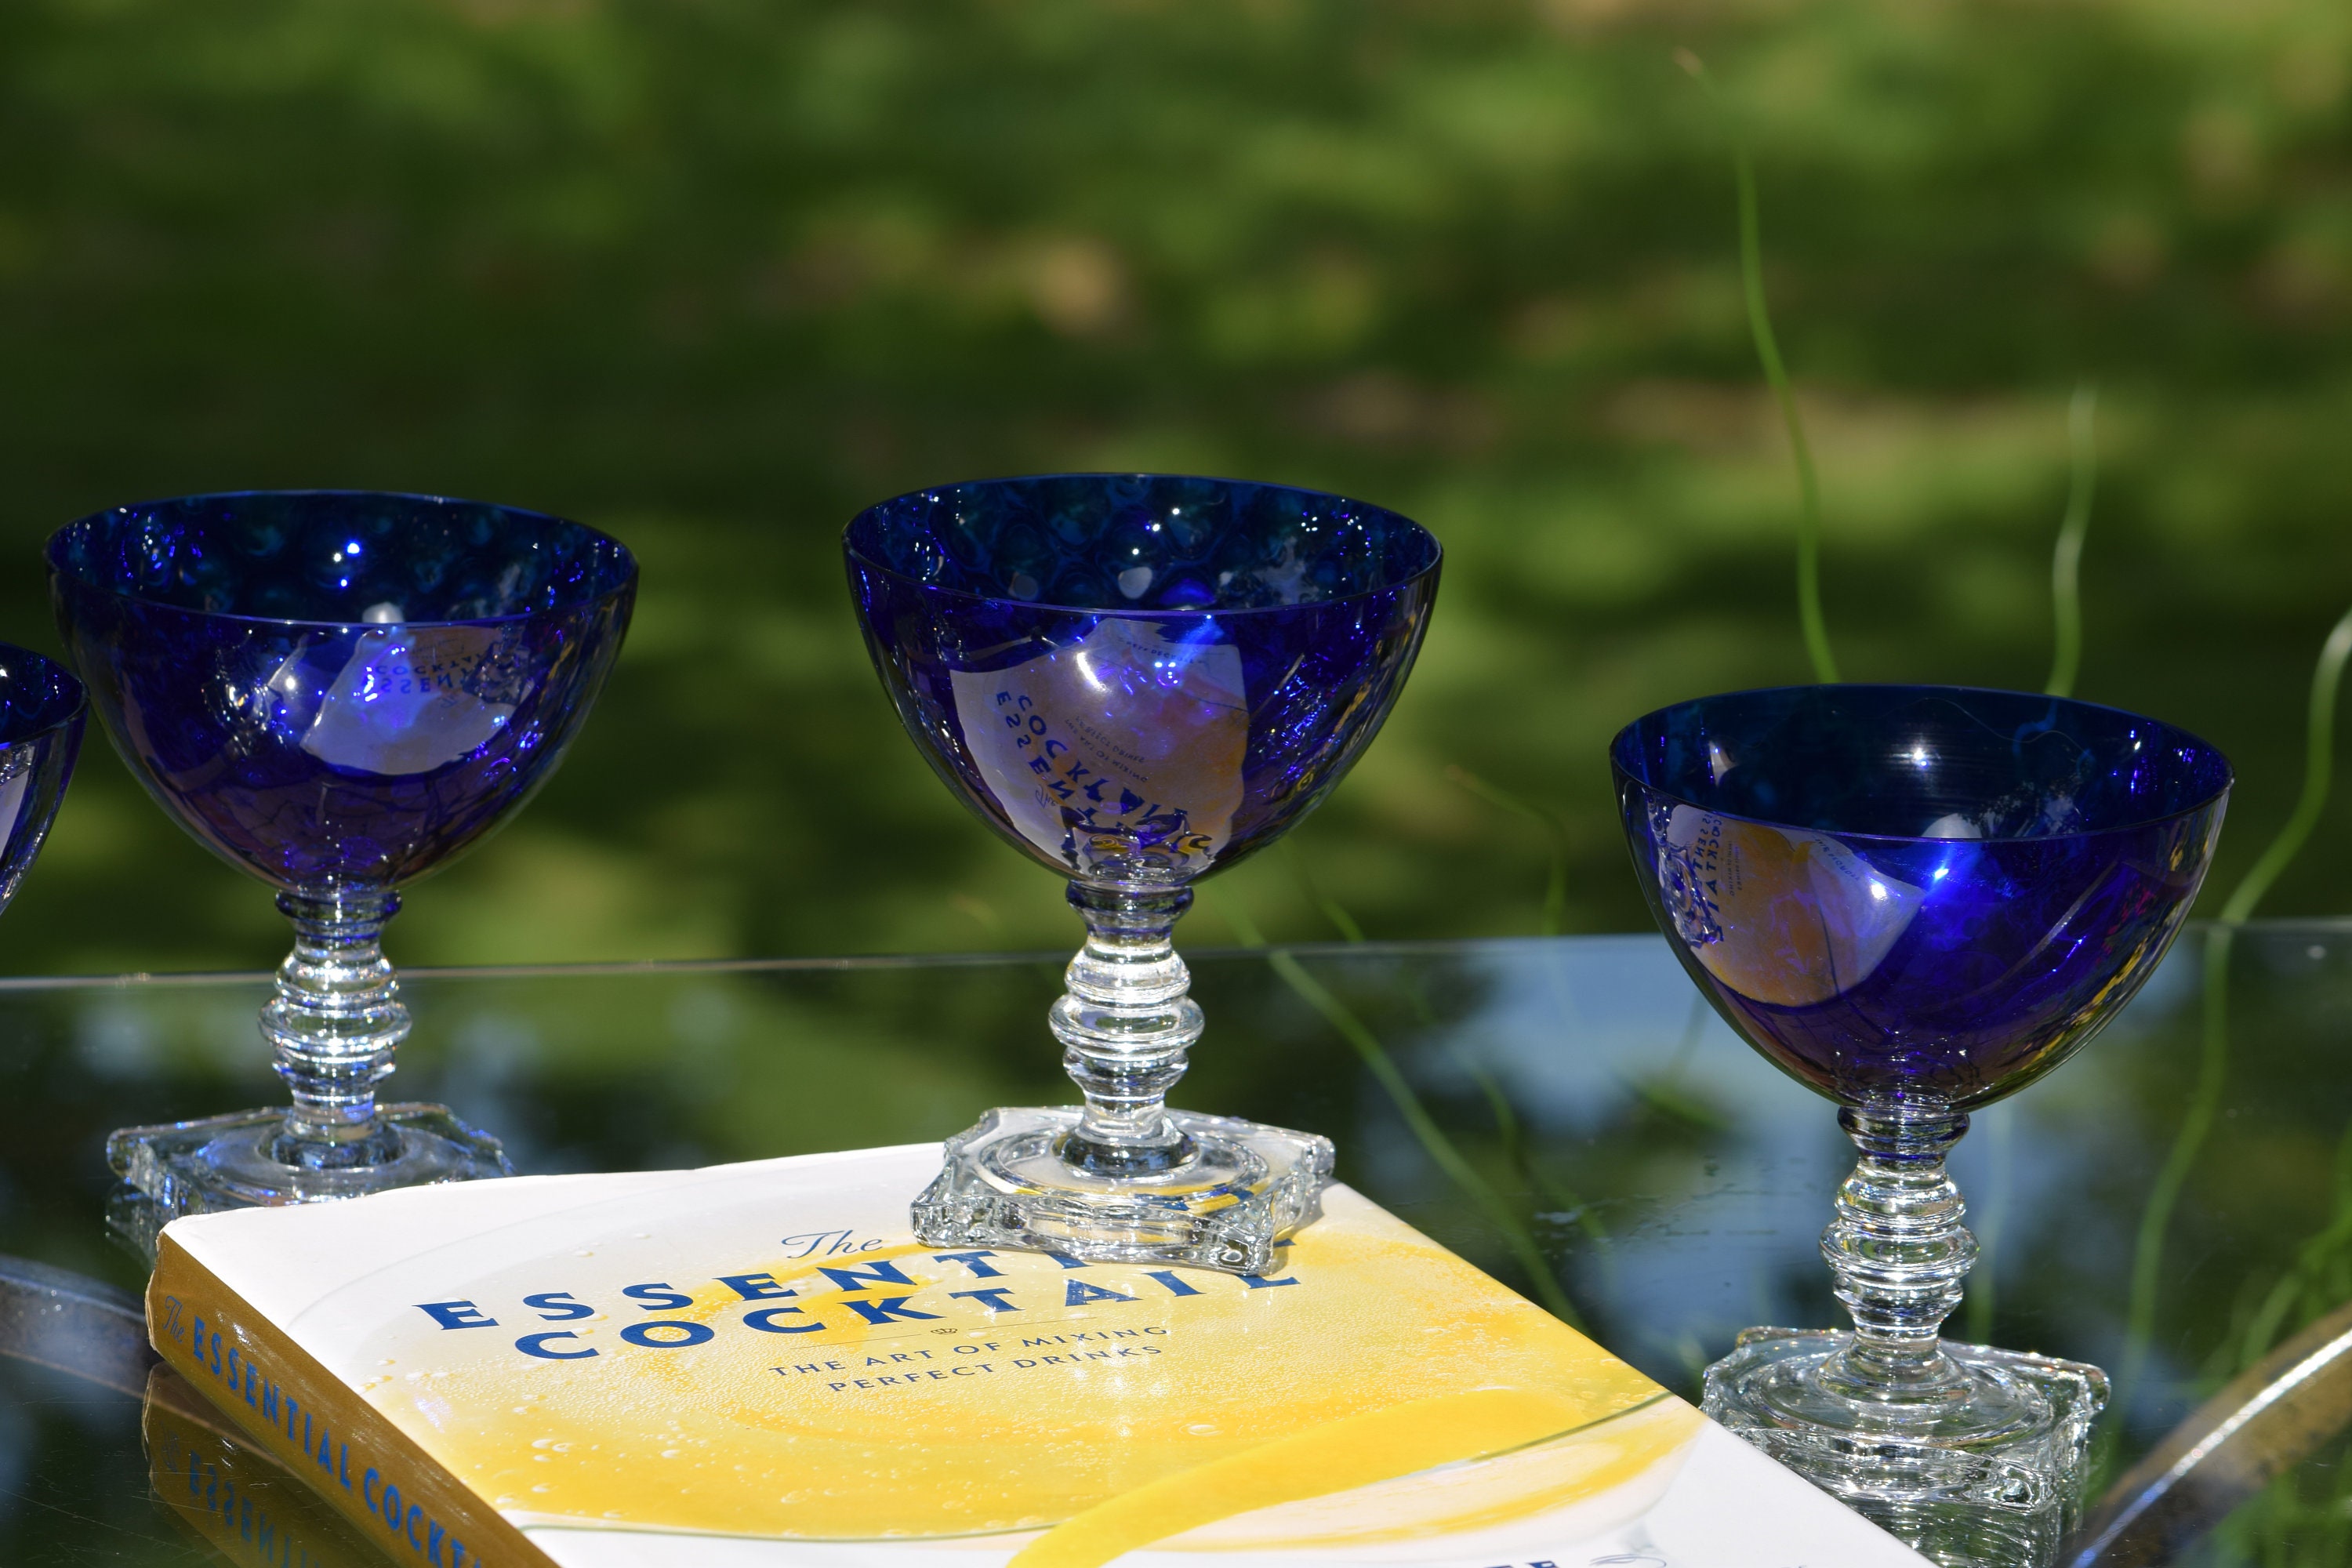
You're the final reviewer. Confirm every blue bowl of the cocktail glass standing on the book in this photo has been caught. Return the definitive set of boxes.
[842,475,1439,886]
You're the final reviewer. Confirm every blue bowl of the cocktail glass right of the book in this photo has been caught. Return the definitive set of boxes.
[1609,687,2230,1112]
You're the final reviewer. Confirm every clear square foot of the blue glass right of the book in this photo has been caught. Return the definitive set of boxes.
[1705,1328,2107,1568]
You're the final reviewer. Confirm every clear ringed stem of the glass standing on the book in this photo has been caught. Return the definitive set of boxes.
[1049,881,1200,1178]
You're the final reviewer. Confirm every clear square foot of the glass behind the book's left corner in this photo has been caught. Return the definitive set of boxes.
[106,1105,515,1258]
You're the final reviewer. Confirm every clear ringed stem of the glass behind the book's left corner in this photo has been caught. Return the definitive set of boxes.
[261,888,409,1171]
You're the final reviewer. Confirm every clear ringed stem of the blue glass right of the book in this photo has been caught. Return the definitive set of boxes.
[1820,1105,1976,1403]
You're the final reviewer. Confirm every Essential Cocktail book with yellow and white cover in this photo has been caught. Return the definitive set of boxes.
[148,1145,1924,1568]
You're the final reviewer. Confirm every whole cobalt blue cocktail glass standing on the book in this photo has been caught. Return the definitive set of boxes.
[842,475,1439,1272]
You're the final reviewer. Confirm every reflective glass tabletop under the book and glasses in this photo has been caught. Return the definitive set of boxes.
[0,921,2352,1566]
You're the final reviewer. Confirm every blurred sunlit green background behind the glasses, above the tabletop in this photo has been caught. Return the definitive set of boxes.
[0,0,2352,971]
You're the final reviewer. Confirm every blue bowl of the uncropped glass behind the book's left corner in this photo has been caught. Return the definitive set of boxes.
[49,492,637,891]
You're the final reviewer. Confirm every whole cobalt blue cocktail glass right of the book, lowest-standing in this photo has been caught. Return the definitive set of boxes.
[1611,687,2230,1563]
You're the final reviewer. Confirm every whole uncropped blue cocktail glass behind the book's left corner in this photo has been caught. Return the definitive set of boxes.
[49,492,637,1239]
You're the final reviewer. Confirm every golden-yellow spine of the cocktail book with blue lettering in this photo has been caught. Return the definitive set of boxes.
[148,1236,557,1568]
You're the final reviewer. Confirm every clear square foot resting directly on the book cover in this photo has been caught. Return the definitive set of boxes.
[915,1105,1331,1274]
